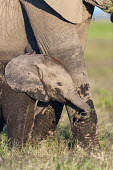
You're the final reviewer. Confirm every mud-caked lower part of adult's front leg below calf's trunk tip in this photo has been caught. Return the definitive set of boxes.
[66,100,99,151]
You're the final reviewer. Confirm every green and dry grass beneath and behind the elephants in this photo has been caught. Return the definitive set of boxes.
[0,22,113,170]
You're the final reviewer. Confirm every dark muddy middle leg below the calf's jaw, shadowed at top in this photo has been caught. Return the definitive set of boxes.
[32,101,63,143]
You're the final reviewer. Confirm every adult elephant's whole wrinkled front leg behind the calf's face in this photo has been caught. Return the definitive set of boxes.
[21,0,98,147]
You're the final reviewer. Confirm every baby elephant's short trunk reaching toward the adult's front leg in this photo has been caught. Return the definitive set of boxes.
[66,91,90,112]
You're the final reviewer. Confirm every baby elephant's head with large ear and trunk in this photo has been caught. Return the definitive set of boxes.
[5,54,90,112]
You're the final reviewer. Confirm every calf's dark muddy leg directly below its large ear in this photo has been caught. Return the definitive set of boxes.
[2,68,35,145]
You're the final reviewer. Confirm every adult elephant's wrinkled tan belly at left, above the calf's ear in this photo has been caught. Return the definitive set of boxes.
[0,0,28,60]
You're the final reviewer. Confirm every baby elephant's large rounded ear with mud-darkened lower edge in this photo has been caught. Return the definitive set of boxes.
[5,54,49,102]
